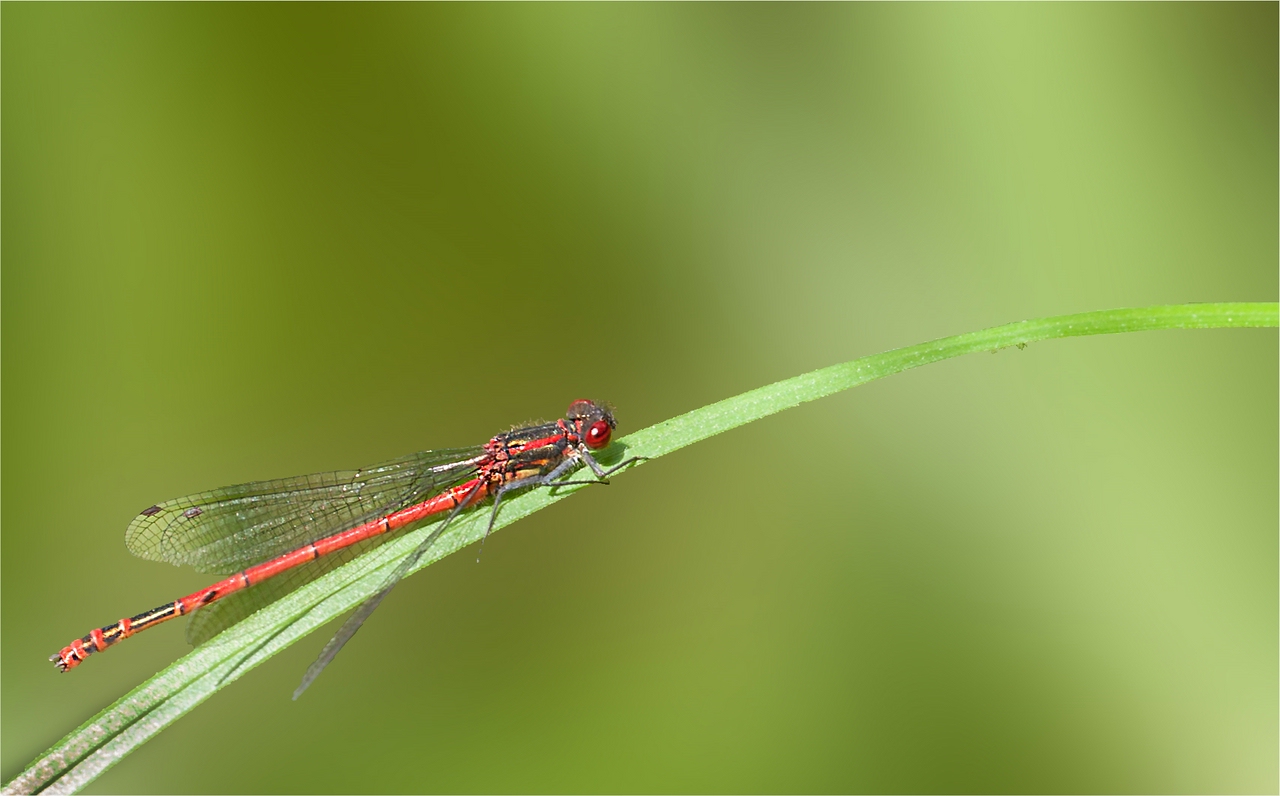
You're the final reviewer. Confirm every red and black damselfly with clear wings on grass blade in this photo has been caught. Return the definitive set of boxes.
[50,399,643,699]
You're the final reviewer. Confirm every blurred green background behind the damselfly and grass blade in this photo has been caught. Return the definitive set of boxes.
[0,4,1280,793]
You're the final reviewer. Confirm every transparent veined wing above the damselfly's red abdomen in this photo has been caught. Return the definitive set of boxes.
[124,447,483,575]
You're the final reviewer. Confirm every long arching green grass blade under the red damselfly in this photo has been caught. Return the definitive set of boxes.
[4,302,1280,793]
